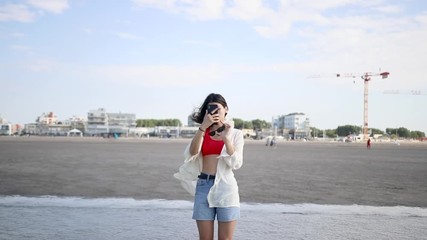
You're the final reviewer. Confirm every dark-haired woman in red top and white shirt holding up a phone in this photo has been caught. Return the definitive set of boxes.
[174,93,244,239]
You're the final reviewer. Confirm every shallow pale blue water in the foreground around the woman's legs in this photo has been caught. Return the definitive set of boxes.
[0,196,427,240]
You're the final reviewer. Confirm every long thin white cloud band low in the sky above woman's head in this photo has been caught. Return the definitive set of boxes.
[93,63,318,88]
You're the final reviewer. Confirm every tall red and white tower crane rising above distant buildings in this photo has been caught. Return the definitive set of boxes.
[310,72,390,140]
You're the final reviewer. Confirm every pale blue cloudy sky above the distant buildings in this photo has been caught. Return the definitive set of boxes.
[0,0,427,133]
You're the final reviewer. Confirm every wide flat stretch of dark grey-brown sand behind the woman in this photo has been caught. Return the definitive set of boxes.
[0,137,427,208]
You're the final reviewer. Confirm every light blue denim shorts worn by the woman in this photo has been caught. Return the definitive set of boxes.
[193,179,240,222]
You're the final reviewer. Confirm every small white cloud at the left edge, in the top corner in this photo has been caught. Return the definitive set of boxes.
[0,4,35,22]
